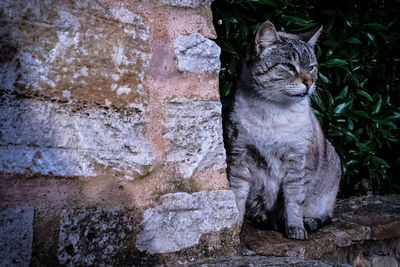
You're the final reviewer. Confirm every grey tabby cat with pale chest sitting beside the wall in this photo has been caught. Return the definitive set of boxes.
[224,21,341,240]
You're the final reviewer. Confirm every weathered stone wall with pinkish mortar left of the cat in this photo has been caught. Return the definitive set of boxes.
[0,0,238,266]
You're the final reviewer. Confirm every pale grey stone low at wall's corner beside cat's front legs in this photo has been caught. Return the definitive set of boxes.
[136,190,238,254]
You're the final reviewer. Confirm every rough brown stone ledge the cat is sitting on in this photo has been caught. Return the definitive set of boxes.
[189,195,400,267]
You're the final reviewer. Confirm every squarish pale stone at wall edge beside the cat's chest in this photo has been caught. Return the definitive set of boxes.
[163,99,226,178]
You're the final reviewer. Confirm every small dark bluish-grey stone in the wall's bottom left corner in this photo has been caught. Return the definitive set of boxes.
[0,207,33,266]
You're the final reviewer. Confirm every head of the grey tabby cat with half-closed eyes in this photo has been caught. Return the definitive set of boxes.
[247,21,322,103]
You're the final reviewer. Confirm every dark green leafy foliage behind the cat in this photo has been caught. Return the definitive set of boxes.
[212,0,400,196]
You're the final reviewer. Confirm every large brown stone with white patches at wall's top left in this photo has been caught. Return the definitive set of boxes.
[0,0,151,107]
